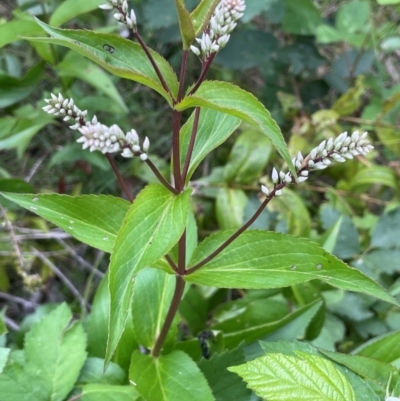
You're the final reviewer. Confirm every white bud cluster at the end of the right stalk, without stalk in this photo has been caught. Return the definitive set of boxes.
[261,131,374,196]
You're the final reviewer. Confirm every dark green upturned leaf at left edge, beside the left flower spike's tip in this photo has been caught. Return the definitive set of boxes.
[0,63,44,109]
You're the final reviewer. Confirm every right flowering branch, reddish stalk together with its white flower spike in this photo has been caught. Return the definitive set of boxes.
[186,131,373,274]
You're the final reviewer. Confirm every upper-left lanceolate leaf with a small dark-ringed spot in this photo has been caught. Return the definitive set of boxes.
[29,20,178,104]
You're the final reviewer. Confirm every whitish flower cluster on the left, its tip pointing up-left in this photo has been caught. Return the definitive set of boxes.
[43,94,150,161]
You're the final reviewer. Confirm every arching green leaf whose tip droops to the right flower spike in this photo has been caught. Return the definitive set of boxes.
[175,81,296,174]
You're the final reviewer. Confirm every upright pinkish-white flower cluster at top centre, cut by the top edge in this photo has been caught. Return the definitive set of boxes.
[190,0,246,61]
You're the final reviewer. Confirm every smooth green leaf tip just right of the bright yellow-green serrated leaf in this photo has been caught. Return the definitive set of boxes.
[319,349,397,389]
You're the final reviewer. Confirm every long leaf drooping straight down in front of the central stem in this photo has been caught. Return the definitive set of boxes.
[106,184,190,361]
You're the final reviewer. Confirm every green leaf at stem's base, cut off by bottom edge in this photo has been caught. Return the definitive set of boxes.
[129,351,215,401]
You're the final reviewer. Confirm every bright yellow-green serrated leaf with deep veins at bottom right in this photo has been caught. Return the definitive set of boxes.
[229,351,356,401]
